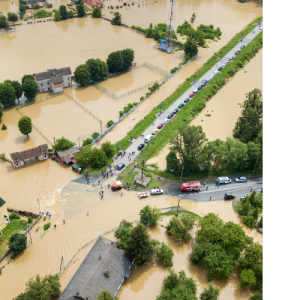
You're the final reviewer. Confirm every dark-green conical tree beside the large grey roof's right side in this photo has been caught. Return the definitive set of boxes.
[125,223,154,266]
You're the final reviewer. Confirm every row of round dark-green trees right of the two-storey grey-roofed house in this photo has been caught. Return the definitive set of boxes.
[74,48,134,85]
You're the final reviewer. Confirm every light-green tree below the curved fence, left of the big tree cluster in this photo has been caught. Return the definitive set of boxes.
[166,213,195,244]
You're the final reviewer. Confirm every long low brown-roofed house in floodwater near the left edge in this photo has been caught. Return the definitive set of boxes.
[10,144,49,168]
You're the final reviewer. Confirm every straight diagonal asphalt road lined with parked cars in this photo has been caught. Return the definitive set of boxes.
[115,23,263,165]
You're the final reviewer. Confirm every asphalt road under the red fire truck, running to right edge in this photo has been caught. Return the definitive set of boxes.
[164,177,263,202]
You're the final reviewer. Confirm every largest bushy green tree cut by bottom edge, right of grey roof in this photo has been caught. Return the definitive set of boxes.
[156,269,197,300]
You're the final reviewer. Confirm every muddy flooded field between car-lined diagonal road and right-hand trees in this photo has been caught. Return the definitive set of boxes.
[148,50,263,170]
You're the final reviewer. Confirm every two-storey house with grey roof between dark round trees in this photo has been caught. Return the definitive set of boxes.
[33,67,72,93]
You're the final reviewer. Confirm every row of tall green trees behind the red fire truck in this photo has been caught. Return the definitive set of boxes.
[166,89,262,176]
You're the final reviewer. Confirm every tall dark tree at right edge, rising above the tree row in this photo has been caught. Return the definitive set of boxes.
[233,89,263,143]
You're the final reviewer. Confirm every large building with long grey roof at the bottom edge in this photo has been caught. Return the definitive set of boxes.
[58,236,133,300]
